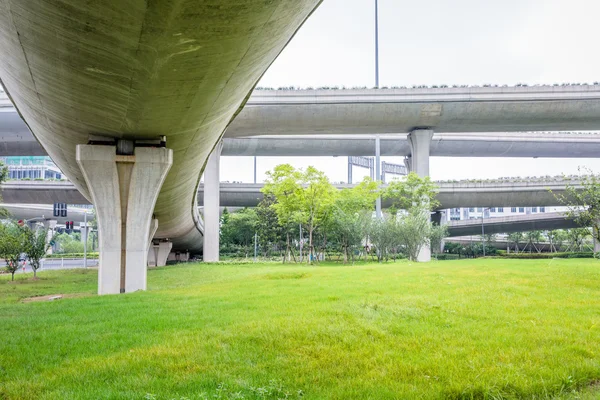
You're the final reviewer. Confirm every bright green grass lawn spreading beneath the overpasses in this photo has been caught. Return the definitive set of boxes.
[0,259,600,400]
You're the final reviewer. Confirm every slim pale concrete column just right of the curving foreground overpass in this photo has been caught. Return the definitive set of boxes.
[202,141,223,262]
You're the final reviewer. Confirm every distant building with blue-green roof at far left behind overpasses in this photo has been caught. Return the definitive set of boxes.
[0,156,66,180]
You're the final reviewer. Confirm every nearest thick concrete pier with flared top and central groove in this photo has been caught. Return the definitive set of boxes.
[76,141,173,294]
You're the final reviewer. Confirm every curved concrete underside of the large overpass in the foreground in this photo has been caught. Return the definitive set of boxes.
[0,0,319,256]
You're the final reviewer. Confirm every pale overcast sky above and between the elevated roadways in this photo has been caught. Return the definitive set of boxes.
[221,0,600,182]
